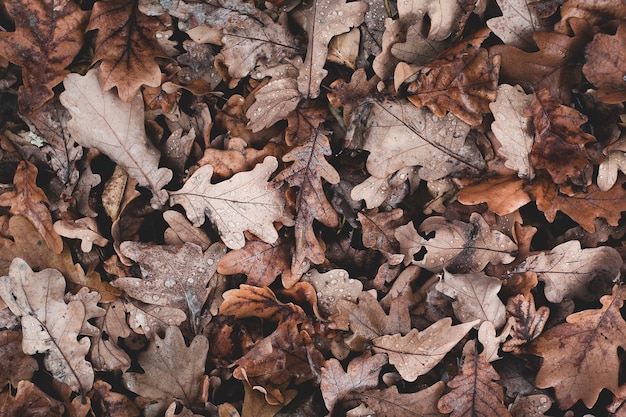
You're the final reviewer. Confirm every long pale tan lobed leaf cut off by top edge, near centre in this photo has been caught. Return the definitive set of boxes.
[296,0,368,98]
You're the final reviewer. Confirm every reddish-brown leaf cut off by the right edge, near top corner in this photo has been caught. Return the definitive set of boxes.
[583,22,626,104]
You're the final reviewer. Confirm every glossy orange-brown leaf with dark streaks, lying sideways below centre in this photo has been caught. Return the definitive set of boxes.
[220,284,308,323]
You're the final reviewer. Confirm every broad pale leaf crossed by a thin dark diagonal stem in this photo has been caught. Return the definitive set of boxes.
[352,100,484,181]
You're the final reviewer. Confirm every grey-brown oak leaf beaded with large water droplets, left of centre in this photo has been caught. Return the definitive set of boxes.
[112,242,226,330]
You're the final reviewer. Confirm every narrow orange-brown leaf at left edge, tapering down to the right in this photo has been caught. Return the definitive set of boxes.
[0,161,63,254]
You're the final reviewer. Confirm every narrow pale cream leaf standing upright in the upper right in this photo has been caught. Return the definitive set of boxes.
[489,84,535,180]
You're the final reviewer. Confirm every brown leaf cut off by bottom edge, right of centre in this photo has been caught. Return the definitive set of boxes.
[359,381,445,417]
